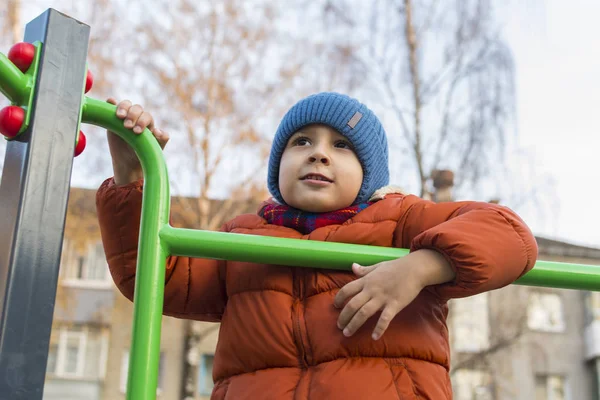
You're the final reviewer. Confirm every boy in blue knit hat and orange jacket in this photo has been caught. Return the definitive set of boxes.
[97,93,537,400]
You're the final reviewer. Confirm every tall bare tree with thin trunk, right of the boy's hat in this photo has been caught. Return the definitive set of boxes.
[314,0,514,200]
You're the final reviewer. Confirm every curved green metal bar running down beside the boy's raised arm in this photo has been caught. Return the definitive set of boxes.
[82,97,170,400]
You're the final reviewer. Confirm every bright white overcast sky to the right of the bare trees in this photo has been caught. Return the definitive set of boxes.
[503,0,600,247]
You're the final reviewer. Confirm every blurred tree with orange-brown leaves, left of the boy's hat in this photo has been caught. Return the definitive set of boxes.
[121,0,324,398]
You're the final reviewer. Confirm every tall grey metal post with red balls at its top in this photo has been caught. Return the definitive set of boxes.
[0,9,89,400]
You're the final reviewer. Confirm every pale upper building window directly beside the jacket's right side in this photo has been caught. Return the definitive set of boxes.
[451,293,490,353]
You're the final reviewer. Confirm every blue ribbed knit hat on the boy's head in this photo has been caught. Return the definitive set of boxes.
[267,93,390,204]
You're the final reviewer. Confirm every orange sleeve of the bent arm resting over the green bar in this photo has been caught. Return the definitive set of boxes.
[394,196,538,299]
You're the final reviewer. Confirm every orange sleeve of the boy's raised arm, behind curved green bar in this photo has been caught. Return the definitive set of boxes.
[96,178,227,322]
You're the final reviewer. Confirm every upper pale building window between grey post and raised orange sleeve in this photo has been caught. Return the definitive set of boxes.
[61,241,111,289]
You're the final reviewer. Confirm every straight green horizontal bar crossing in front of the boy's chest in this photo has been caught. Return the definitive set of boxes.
[160,225,600,291]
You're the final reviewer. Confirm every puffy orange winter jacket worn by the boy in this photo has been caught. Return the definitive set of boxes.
[97,179,537,400]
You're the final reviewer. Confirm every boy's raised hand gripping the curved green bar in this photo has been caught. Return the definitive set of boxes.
[106,97,169,186]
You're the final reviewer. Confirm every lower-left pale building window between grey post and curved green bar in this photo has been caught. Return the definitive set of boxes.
[46,326,108,379]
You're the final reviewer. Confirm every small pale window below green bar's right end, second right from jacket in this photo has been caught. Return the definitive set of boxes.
[527,292,565,332]
